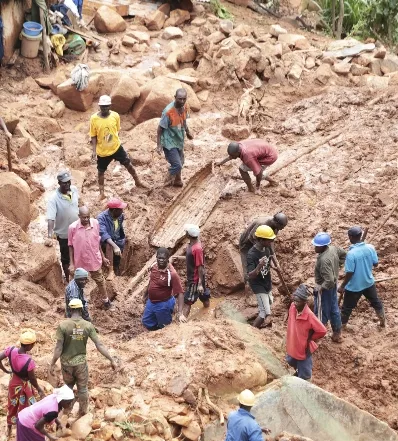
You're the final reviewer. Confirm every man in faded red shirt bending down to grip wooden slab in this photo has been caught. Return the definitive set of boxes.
[215,139,278,195]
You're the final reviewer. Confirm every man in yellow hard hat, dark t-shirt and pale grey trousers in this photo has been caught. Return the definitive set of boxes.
[247,225,276,328]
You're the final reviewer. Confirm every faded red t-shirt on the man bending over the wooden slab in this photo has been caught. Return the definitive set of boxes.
[239,139,278,176]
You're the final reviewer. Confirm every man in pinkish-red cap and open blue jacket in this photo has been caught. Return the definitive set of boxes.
[97,198,127,280]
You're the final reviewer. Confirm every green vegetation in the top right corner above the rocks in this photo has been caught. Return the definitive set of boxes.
[319,0,398,44]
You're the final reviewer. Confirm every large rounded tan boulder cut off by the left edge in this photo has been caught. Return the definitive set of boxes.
[0,172,30,231]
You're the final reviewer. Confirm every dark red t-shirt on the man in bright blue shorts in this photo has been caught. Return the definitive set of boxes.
[148,263,183,303]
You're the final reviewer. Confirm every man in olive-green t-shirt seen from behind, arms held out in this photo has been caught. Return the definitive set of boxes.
[50,299,116,417]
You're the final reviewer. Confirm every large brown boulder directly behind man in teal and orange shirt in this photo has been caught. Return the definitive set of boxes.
[133,76,201,124]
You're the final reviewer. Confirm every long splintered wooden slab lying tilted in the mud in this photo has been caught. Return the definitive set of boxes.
[151,163,225,248]
